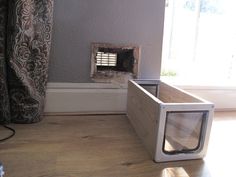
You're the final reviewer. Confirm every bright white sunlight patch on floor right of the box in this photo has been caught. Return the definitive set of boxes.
[204,113,236,177]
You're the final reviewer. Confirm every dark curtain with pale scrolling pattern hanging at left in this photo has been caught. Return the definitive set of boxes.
[0,0,53,124]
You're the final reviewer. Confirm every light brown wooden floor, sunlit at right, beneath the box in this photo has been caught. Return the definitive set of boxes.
[0,112,236,177]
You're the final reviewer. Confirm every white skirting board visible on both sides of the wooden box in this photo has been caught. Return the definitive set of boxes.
[45,83,236,115]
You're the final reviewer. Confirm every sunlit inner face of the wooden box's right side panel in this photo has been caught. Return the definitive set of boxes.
[159,82,202,103]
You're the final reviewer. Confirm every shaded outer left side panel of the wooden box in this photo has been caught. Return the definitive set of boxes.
[127,82,159,158]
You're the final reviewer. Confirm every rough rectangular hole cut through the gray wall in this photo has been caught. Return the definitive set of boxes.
[91,43,140,83]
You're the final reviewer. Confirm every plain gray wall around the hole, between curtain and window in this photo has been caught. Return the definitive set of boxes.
[49,0,164,82]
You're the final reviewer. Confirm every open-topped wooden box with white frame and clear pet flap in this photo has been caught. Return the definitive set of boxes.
[127,80,214,162]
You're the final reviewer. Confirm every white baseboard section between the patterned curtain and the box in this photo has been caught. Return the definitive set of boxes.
[45,83,127,114]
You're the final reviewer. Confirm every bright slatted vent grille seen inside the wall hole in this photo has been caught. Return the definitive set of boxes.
[96,52,117,66]
